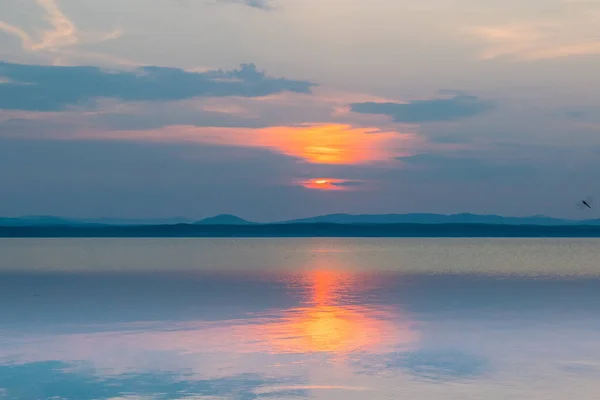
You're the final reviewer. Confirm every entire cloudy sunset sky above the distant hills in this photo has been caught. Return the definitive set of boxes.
[0,0,600,222]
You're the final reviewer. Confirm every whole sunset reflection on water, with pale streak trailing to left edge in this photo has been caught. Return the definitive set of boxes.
[0,255,419,370]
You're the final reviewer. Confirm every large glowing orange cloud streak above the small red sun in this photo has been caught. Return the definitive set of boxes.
[75,124,424,164]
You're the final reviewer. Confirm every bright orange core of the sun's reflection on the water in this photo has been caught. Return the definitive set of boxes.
[258,269,418,356]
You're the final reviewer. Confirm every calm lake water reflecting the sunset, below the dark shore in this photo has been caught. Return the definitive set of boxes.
[0,239,600,400]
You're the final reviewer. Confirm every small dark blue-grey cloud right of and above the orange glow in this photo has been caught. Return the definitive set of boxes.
[350,94,492,123]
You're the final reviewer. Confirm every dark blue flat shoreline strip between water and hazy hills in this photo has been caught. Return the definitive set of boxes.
[0,223,600,238]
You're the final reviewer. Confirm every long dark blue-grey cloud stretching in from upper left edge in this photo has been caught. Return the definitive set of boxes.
[0,62,314,111]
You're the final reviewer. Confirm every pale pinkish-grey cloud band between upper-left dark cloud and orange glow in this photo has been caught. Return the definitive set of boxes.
[0,86,400,132]
